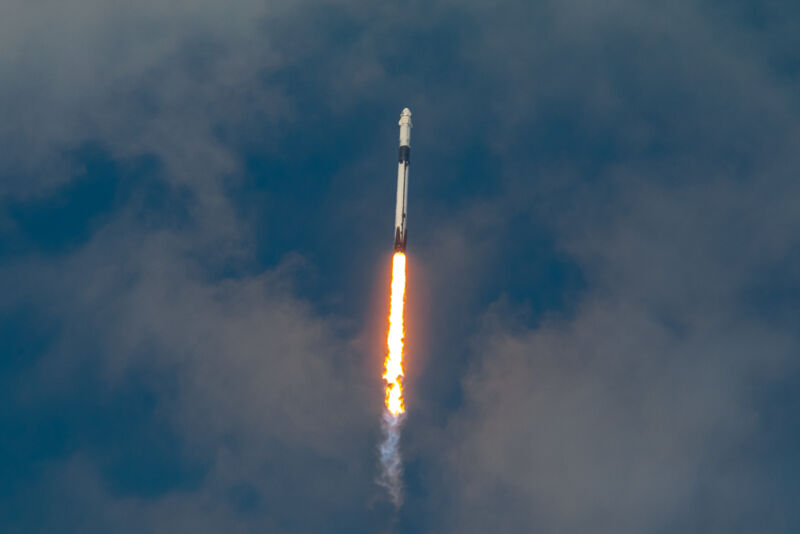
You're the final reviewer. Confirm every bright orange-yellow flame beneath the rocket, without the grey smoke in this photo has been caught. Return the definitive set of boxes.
[383,252,406,416]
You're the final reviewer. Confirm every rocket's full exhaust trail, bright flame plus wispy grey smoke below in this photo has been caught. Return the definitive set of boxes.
[378,252,406,508]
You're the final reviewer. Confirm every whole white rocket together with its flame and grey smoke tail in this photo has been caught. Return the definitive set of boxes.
[378,108,411,508]
